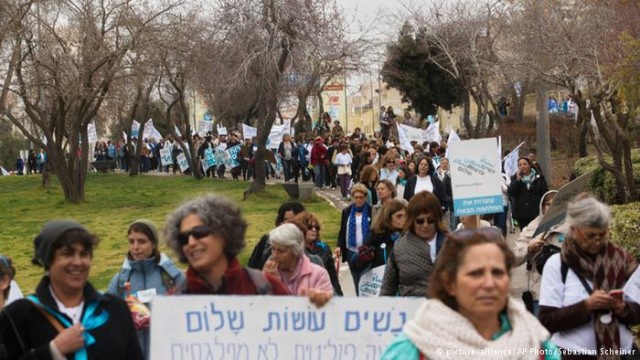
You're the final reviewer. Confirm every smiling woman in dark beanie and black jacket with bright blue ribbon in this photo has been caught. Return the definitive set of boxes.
[0,220,142,360]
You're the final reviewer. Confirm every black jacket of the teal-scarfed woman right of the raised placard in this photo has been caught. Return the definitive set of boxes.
[508,175,549,220]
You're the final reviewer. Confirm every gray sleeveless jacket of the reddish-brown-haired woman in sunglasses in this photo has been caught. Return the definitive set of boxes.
[380,233,446,297]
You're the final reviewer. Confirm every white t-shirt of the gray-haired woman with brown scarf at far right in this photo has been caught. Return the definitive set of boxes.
[540,254,633,354]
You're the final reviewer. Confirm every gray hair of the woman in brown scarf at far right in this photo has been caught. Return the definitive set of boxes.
[565,193,611,228]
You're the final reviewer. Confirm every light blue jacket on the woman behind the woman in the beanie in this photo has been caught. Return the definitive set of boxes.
[107,254,185,359]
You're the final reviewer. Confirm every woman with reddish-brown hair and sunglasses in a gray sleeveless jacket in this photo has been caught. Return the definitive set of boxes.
[380,191,447,297]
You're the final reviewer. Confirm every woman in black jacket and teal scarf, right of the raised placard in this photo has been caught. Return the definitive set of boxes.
[508,157,549,231]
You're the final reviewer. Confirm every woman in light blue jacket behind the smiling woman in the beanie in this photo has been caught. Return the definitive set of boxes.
[107,219,184,359]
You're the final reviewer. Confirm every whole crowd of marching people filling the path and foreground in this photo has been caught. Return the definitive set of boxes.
[0,113,640,359]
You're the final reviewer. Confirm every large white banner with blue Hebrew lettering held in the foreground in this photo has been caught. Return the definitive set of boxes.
[151,296,424,360]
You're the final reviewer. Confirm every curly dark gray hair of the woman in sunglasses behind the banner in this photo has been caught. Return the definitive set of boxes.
[164,194,247,263]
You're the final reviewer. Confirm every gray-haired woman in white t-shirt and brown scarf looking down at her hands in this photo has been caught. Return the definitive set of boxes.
[538,193,640,359]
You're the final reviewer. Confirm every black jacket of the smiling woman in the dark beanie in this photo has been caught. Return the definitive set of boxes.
[0,276,143,360]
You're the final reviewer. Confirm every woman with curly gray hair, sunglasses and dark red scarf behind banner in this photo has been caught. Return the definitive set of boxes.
[165,195,289,295]
